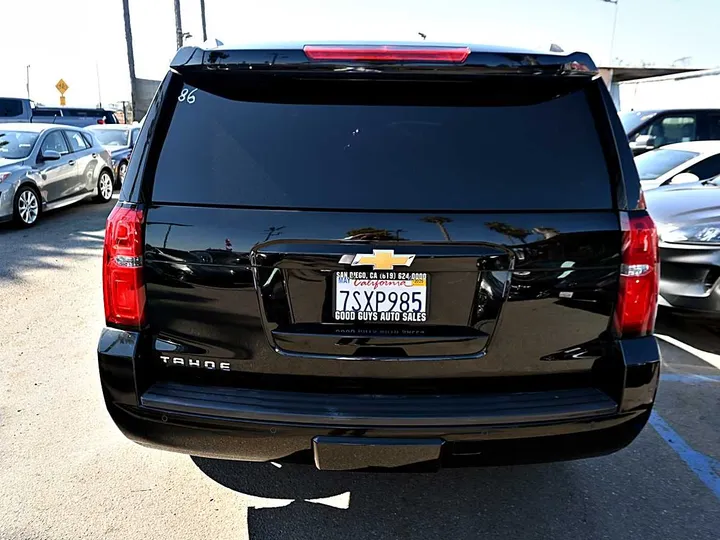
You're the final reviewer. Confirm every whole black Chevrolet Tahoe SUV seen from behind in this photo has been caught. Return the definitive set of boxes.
[98,44,660,469]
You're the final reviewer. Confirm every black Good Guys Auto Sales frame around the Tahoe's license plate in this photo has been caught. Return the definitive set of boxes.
[331,271,430,324]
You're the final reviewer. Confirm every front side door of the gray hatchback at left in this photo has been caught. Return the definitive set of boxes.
[38,129,77,203]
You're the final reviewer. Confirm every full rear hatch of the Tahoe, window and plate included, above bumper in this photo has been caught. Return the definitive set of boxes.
[134,44,621,393]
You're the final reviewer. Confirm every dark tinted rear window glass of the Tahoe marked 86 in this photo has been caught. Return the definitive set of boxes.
[153,79,612,210]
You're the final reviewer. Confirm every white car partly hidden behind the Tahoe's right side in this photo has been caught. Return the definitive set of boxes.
[635,141,720,191]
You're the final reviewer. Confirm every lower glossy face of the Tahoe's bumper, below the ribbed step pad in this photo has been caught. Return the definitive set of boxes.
[108,404,650,469]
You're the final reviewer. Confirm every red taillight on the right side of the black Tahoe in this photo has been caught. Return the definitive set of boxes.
[615,212,659,337]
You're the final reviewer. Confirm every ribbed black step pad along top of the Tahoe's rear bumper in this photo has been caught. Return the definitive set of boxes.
[140,383,618,430]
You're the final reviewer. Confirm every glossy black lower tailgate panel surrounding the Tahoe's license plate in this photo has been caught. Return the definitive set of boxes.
[145,206,620,378]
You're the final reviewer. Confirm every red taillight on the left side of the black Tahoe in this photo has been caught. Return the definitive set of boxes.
[103,206,145,327]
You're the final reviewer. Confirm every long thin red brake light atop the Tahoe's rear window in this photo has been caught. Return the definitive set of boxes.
[303,45,470,64]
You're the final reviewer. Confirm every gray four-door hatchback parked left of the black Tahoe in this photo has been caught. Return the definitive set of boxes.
[0,124,113,227]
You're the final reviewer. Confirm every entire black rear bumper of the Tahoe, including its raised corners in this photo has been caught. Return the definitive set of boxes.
[98,330,660,469]
